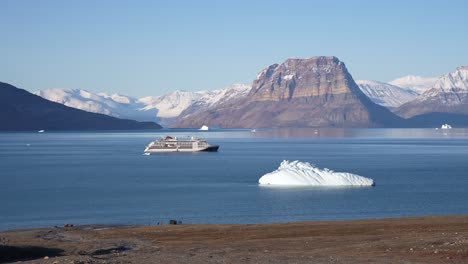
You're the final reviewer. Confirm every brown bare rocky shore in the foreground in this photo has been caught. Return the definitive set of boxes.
[0,216,468,263]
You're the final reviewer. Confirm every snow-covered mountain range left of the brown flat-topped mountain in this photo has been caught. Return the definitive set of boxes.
[34,84,250,125]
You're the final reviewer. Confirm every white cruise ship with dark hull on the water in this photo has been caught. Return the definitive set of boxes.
[145,136,219,154]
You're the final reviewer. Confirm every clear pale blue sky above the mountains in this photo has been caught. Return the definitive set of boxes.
[0,0,468,96]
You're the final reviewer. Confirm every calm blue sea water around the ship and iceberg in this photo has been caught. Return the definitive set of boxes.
[0,129,468,230]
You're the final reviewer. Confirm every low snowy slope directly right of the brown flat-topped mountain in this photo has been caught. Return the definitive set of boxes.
[356,80,418,108]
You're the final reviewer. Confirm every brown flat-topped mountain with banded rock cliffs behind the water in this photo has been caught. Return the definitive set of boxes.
[176,57,403,128]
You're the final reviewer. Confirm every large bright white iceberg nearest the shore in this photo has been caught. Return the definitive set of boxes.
[258,160,374,186]
